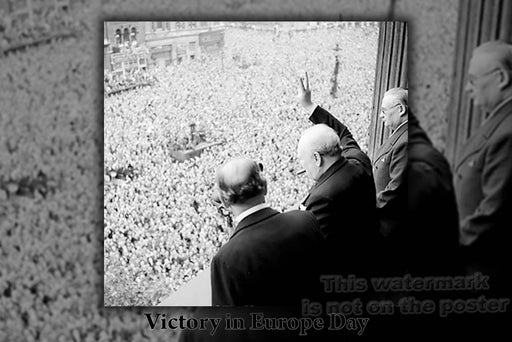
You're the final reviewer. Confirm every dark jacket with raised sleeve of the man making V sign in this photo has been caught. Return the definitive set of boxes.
[303,106,378,275]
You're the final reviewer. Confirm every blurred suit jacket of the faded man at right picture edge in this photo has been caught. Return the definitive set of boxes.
[454,99,512,255]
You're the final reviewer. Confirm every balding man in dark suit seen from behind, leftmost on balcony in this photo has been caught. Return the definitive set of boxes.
[211,158,325,306]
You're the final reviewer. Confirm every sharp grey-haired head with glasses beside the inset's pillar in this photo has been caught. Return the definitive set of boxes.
[379,87,409,130]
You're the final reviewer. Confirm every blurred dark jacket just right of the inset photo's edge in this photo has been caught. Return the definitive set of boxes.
[408,113,461,278]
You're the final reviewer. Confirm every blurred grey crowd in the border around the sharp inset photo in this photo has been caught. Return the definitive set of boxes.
[0,0,466,341]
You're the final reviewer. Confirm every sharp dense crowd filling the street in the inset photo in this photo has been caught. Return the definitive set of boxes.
[104,26,378,305]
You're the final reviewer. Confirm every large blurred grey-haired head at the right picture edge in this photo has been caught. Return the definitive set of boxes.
[465,40,512,113]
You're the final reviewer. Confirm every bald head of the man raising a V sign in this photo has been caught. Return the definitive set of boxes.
[297,124,341,181]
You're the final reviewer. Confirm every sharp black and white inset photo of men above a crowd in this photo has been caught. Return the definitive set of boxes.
[104,22,392,306]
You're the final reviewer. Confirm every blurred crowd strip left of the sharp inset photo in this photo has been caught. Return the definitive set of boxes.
[0,1,146,342]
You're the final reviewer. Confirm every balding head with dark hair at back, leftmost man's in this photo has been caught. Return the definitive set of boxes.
[216,158,267,207]
